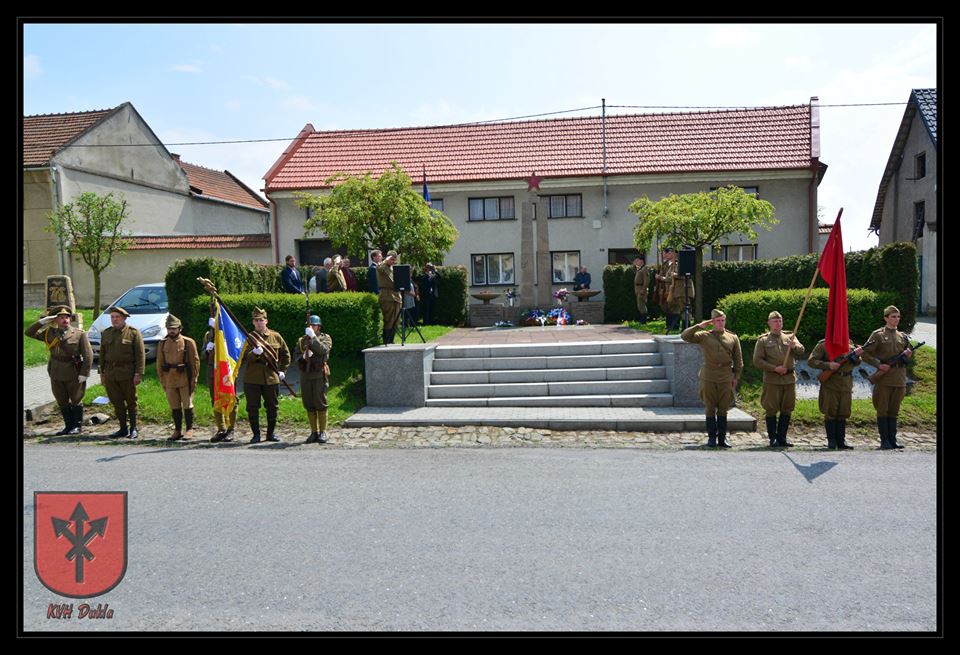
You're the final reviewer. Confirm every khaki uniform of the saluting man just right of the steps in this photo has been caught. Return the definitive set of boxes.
[680,325,743,416]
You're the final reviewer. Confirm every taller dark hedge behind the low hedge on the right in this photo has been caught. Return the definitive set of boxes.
[704,243,920,334]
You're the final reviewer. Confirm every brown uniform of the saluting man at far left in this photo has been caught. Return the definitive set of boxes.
[25,321,93,407]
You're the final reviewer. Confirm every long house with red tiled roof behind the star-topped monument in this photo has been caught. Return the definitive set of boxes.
[264,97,827,299]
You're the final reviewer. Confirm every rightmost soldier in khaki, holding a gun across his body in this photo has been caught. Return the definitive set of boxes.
[857,305,913,450]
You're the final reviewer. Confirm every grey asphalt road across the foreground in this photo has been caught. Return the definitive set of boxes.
[23,445,937,632]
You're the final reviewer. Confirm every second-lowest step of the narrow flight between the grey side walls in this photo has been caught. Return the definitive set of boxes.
[427,380,670,399]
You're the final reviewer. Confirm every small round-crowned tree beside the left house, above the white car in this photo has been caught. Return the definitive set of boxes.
[44,191,132,316]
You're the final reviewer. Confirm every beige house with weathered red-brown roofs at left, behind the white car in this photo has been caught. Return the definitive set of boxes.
[23,102,273,305]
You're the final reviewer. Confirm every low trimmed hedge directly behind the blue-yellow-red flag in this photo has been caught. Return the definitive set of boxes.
[181,291,383,364]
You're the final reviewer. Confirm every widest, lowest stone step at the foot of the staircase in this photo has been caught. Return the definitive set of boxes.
[343,406,757,433]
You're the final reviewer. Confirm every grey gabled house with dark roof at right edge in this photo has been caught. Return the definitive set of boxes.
[870,89,939,315]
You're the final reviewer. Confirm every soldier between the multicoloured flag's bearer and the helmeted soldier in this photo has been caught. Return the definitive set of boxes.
[243,307,290,443]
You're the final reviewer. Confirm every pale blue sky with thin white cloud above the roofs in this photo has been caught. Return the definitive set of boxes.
[23,24,937,249]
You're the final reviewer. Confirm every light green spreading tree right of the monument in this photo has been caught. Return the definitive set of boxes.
[630,185,780,317]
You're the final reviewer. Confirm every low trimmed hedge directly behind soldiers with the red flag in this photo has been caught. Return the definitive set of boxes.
[717,288,902,348]
